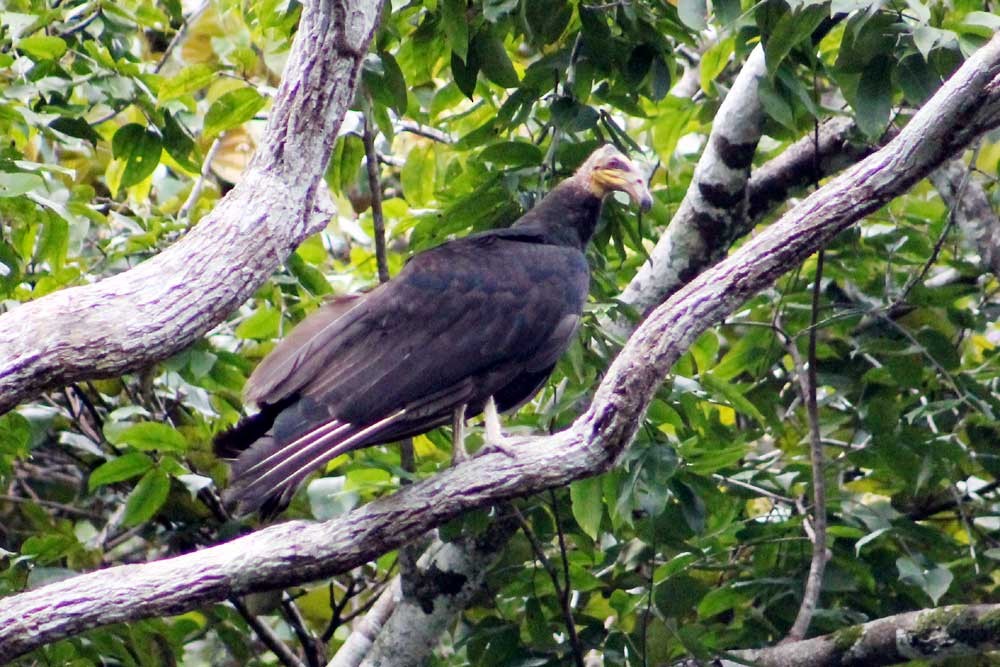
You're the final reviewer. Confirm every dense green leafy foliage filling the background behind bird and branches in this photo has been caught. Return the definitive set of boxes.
[0,0,1000,665]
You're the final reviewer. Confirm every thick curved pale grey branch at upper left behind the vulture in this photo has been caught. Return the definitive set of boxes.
[0,0,381,414]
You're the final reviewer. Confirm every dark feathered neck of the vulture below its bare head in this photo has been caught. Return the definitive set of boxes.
[516,177,601,250]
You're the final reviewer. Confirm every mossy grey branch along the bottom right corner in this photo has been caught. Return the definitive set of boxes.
[675,604,1000,667]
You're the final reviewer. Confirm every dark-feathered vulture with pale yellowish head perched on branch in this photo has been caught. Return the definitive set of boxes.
[215,145,652,516]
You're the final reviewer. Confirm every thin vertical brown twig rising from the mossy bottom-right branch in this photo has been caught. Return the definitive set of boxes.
[787,249,827,641]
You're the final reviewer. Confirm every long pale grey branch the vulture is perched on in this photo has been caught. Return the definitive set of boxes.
[0,35,1000,661]
